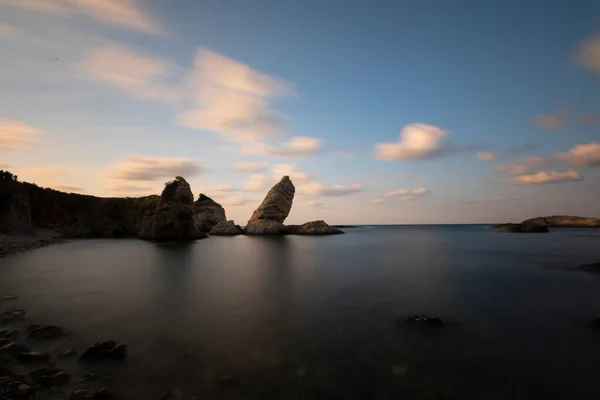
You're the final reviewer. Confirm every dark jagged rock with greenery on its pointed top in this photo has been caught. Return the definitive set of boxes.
[140,176,207,240]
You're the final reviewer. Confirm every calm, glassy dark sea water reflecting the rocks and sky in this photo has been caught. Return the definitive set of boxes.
[0,225,600,399]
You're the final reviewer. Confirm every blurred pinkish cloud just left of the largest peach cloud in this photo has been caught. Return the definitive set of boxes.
[78,43,181,103]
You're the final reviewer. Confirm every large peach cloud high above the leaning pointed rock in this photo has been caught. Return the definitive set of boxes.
[178,49,294,143]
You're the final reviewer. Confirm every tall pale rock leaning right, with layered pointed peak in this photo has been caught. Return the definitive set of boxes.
[246,175,296,235]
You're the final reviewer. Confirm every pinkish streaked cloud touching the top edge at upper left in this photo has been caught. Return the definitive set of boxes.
[3,0,164,35]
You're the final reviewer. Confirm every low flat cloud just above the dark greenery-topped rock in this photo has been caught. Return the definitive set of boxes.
[108,156,202,181]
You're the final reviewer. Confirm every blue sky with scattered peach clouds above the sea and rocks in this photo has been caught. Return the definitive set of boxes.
[0,0,600,225]
